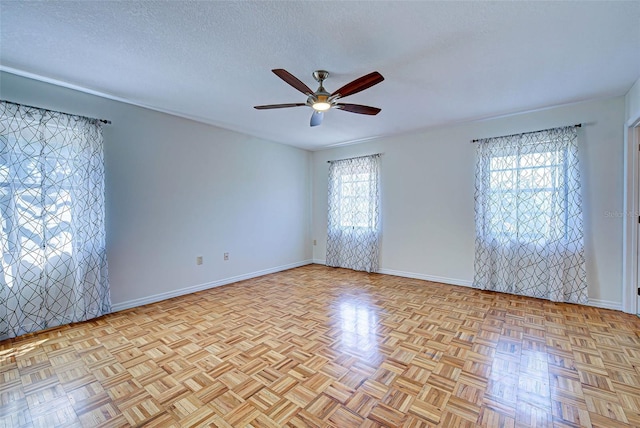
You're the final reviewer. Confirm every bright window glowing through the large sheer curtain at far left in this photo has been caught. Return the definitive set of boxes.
[0,130,73,276]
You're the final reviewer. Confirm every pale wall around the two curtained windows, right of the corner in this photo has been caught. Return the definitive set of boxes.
[311,97,625,309]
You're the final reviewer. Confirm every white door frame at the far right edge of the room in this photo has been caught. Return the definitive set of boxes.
[622,117,640,314]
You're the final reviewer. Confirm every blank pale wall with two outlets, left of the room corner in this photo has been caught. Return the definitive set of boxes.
[0,73,311,309]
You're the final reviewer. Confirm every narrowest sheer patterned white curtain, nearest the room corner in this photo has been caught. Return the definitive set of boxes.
[326,154,380,272]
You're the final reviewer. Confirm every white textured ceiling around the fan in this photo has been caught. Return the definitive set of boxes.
[0,0,640,150]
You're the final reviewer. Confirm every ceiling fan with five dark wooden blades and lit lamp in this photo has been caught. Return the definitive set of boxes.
[254,68,384,126]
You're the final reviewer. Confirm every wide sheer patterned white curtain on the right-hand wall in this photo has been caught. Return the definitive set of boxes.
[473,126,587,303]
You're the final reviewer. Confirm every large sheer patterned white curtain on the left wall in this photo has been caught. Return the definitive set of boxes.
[0,101,111,339]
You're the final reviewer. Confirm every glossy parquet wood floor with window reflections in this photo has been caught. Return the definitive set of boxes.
[0,265,640,428]
